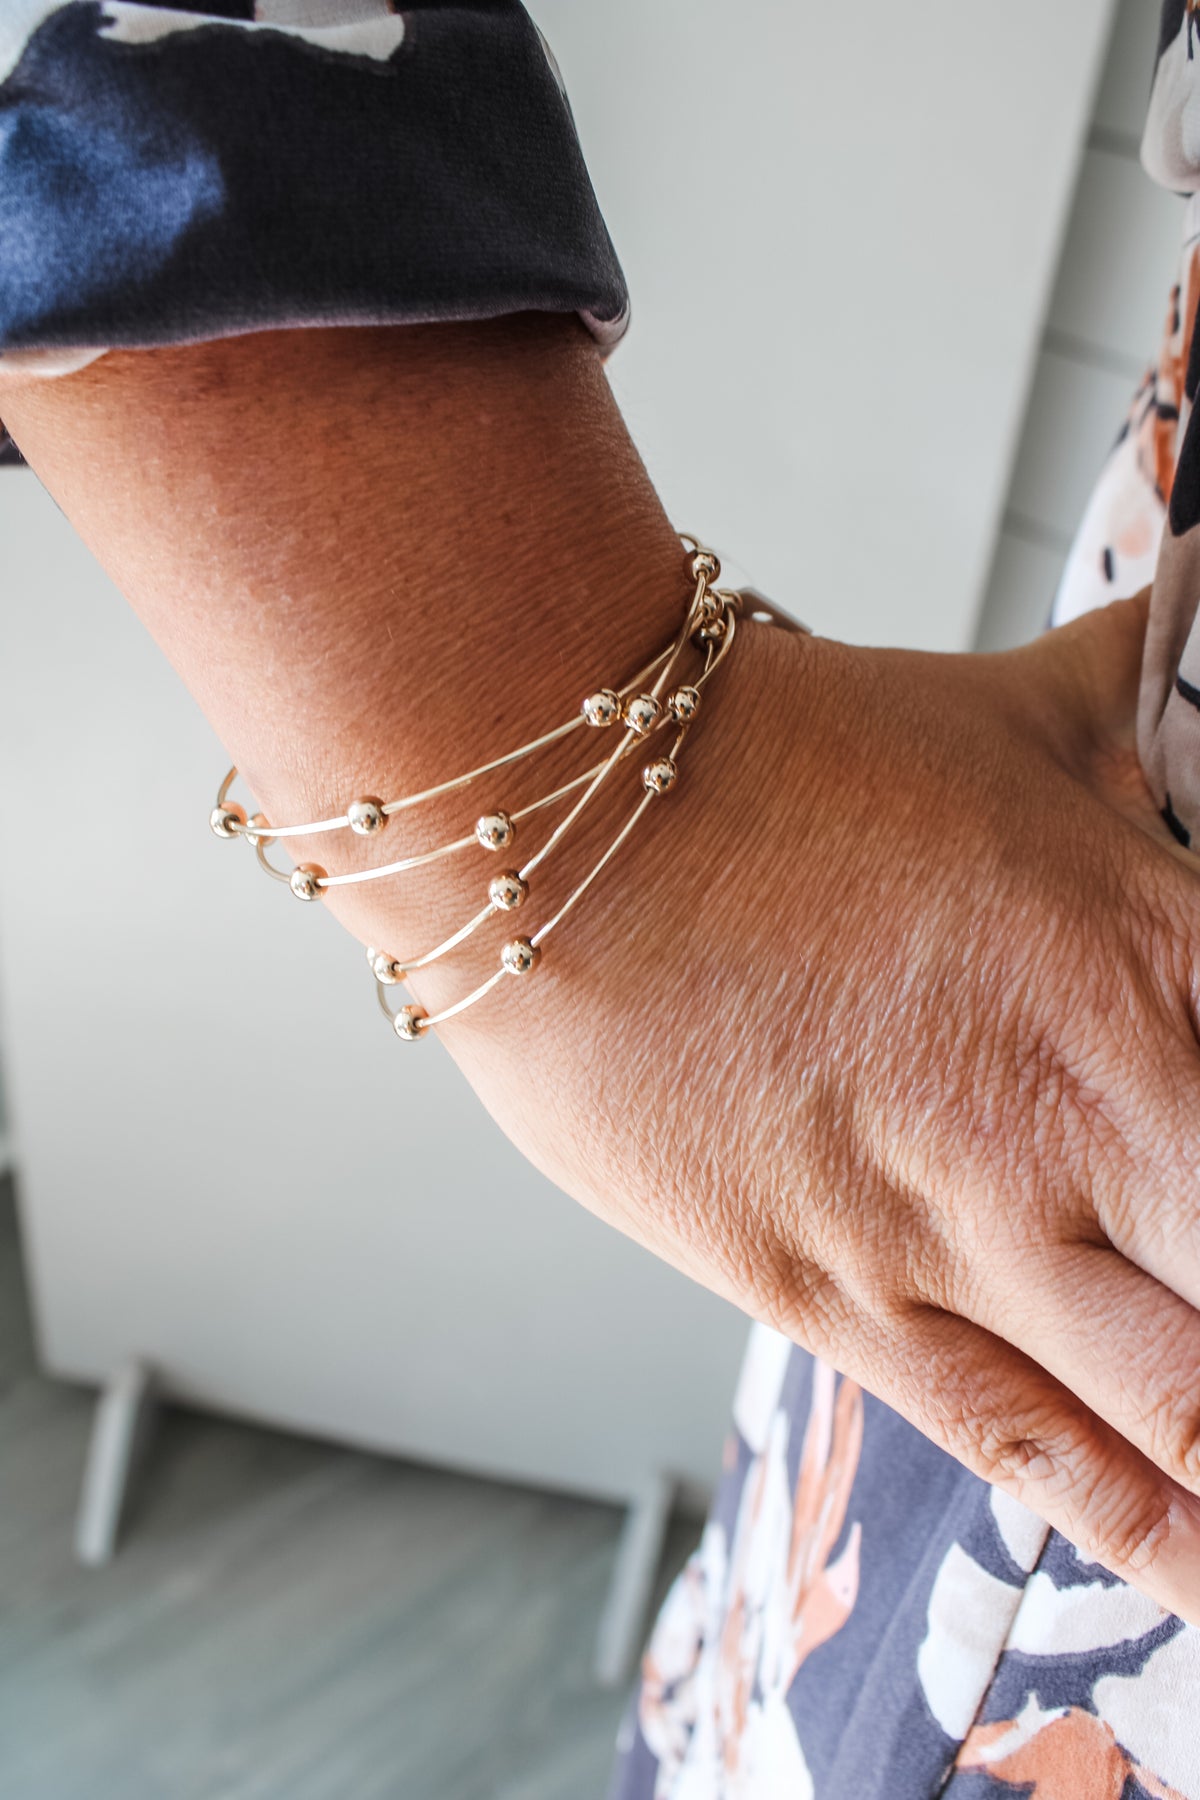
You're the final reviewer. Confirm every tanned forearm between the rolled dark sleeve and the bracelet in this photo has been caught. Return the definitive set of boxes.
[4,315,687,1000]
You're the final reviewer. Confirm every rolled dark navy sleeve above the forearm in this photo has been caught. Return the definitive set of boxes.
[0,0,628,464]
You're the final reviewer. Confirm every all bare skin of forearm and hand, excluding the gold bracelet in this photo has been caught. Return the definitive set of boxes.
[2,317,1200,1624]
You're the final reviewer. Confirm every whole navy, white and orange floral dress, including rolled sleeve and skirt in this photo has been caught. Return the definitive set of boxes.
[0,0,1200,1800]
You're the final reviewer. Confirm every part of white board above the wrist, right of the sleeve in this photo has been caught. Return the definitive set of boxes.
[533,0,1115,650]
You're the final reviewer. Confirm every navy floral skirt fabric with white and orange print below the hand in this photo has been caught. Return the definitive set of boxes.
[610,1327,1200,1800]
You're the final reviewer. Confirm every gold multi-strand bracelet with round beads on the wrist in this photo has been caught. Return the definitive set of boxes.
[209,538,802,1040]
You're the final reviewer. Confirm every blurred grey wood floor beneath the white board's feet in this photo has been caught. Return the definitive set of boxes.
[0,1184,696,1800]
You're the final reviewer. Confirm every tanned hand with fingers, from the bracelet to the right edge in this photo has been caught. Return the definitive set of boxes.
[440,599,1200,1624]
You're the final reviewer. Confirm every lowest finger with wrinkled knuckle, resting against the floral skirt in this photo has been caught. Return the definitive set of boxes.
[877,1307,1200,1625]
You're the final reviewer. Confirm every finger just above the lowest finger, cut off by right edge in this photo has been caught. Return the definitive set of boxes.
[973,1244,1200,1492]
